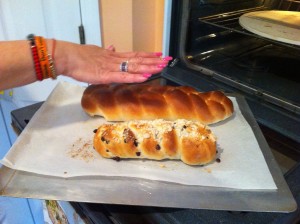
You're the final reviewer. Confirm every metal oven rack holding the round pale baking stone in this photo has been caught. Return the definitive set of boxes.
[196,7,300,50]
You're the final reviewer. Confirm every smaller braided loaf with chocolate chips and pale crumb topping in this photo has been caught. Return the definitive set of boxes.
[94,119,216,165]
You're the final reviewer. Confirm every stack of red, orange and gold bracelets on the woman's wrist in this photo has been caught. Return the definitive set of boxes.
[28,34,56,81]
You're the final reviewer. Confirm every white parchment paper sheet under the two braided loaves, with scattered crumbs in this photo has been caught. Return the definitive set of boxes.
[1,83,277,190]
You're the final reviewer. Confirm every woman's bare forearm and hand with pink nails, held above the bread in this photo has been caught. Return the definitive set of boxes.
[0,39,172,90]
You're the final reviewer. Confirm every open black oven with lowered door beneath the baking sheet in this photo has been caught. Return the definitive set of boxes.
[4,0,300,223]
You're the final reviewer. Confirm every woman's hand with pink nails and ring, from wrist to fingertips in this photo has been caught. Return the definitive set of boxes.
[54,41,172,84]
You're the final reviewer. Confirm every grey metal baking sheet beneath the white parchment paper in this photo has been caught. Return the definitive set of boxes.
[0,96,297,212]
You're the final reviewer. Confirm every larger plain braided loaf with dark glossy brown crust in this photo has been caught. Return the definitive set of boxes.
[81,84,233,124]
